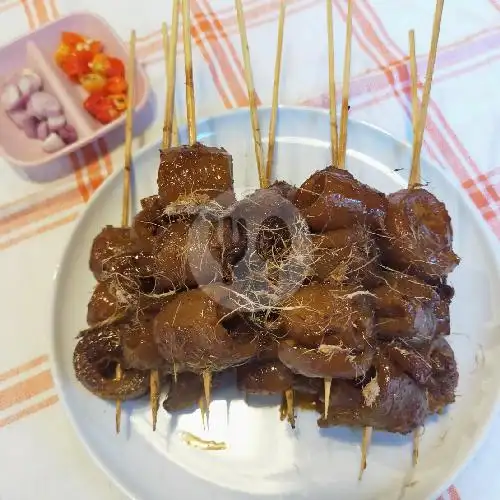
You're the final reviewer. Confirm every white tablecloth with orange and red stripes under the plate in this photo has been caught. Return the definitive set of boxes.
[0,0,500,500]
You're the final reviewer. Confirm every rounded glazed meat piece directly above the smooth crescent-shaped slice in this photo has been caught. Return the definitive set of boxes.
[281,283,373,348]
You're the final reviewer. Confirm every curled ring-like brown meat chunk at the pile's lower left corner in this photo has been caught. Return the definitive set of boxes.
[73,325,149,400]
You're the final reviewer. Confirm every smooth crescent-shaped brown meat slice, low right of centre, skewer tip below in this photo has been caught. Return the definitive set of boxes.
[278,340,373,379]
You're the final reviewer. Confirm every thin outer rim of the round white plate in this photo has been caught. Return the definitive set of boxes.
[49,105,500,498]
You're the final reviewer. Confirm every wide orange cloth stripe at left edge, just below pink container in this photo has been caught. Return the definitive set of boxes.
[0,188,81,236]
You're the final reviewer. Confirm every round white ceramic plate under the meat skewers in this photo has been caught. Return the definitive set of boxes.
[51,107,500,500]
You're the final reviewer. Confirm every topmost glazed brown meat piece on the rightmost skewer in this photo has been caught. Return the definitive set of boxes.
[381,189,460,279]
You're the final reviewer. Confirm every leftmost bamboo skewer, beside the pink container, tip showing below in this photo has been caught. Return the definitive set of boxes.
[115,30,136,434]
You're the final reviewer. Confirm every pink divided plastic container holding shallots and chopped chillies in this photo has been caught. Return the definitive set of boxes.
[0,12,150,168]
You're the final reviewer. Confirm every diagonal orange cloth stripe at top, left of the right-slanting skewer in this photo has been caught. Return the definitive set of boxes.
[195,0,249,106]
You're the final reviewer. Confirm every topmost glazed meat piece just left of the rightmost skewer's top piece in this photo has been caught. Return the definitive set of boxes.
[294,167,387,232]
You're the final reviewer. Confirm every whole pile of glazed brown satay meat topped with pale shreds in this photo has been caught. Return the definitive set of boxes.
[74,143,459,434]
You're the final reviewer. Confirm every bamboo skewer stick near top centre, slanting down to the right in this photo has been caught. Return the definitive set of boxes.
[235,0,267,188]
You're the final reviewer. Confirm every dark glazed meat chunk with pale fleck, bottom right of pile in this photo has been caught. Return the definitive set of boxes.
[318,355,429,434]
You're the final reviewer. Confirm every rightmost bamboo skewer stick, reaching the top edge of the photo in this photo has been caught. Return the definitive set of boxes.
[411,0,444,180]
